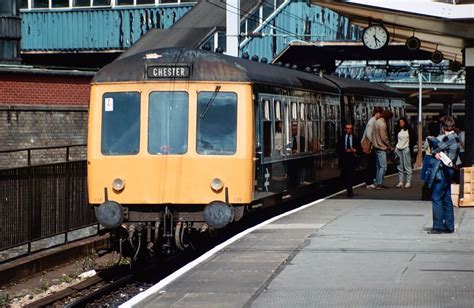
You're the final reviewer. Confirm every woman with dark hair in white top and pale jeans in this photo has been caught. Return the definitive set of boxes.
[395,118,415,188]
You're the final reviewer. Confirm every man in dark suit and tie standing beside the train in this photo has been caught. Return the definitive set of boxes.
[337,124,360,197]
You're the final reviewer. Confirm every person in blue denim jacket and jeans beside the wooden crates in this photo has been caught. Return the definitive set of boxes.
[428,116,460,234]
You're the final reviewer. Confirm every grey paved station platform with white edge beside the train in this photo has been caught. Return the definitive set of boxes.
[124,172,474,307]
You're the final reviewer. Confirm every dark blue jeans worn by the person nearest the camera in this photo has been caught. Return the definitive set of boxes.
[431,168,454,231]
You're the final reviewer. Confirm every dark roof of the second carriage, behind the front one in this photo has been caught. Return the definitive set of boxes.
[324,75,404,98]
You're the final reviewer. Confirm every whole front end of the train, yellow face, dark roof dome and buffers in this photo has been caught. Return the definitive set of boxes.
[88,49,262,255]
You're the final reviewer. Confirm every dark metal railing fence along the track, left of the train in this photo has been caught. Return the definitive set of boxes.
[0,145,98,262]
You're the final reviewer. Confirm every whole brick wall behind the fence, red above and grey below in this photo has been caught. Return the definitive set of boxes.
[0,71,92,169]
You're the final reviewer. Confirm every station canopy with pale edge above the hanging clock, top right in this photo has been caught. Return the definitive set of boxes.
[312,0,474,63]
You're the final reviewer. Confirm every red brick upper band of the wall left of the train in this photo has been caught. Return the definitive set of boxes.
[0,72,92,106]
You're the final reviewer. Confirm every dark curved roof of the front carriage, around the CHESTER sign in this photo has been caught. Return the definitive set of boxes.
[93,48,339,93]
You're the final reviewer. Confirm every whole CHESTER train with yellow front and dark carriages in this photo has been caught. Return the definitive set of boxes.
[87,48,405,253]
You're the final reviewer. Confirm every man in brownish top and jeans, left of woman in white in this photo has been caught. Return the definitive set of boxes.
[372,109,393,190]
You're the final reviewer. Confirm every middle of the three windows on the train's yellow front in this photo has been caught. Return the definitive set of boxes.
[148,92,189,155]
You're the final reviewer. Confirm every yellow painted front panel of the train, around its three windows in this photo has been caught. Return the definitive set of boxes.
[88,82,255,204]
